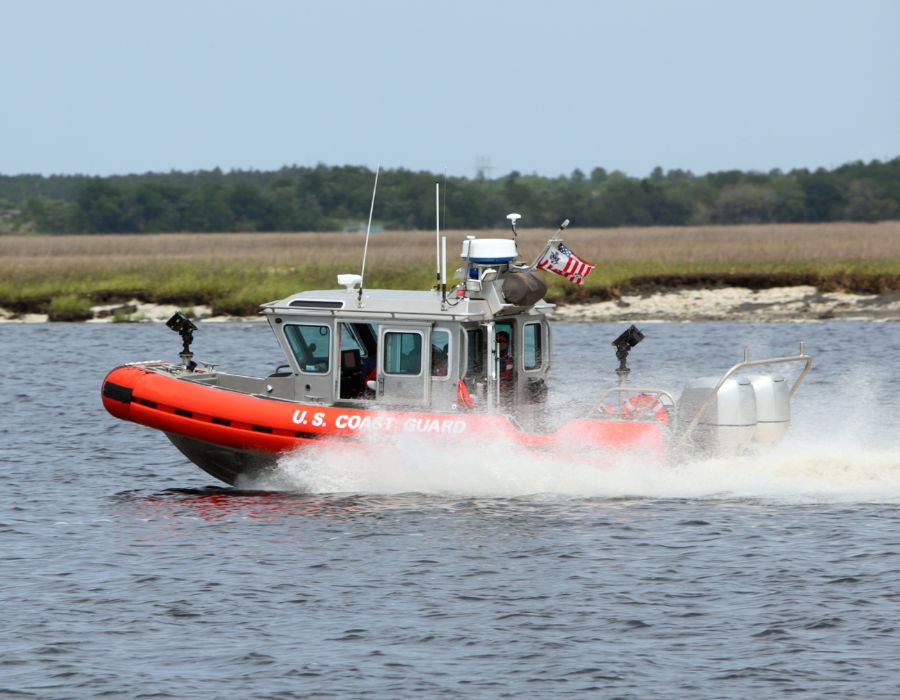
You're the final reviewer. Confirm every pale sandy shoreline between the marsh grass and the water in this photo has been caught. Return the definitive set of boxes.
[0,286,900,323]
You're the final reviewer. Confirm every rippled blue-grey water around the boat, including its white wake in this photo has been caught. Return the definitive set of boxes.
[0,322,900,698]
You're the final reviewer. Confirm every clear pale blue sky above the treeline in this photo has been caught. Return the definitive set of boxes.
[0,0,900,177]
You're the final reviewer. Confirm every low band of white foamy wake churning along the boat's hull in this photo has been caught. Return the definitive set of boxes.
[239,436,900,503]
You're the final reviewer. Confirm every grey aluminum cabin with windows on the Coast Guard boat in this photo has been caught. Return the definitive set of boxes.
[261,239,555,428]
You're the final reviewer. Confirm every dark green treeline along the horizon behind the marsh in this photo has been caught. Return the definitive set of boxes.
[0,158,900,233]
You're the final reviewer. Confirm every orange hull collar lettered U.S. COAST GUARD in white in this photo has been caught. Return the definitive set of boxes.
[102,365,664,458]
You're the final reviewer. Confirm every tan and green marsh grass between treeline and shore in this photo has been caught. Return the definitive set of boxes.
[0,222,900,314]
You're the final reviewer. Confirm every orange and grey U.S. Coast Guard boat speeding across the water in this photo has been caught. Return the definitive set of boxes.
[102,215,811,484]
